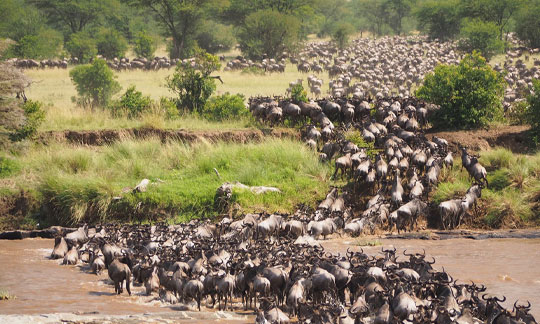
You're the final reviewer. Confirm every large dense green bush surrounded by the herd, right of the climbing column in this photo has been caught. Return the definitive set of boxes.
[416,52,505,129]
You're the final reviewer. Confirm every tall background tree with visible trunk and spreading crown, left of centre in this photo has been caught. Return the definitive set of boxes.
[130,0,210,58]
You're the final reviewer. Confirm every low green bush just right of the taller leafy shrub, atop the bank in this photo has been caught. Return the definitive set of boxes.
[202,92,249,121]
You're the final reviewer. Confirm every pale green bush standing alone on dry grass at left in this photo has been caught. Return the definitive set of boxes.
[69,59,121,108]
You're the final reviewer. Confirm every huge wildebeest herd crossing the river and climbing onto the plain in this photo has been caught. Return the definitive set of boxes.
[32,37,540,324]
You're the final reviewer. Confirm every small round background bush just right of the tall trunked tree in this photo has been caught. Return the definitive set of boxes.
[196,21,236,54]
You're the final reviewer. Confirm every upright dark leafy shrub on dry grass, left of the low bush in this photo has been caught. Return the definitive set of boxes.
[167,50,221,113]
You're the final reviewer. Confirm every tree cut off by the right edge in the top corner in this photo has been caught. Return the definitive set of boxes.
[516,1,540,48]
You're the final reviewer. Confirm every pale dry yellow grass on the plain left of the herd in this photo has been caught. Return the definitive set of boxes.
[25,64,328,131]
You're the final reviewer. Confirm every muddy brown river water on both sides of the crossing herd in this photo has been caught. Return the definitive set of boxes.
[0,238,540,323]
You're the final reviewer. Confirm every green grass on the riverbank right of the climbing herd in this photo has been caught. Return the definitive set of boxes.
[433,148,540,228]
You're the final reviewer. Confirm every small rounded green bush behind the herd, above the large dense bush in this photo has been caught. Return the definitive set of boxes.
[459,19,504,60]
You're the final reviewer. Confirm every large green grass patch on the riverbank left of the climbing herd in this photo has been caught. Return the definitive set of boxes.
[0,139,329,224]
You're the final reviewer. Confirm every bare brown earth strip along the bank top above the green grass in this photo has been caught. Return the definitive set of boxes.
[39,128,300,145]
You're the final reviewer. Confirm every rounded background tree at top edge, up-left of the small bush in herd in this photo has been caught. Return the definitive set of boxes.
[416,0,461,41]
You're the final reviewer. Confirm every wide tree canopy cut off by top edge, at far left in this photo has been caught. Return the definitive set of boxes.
[29,0,113,33]
